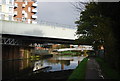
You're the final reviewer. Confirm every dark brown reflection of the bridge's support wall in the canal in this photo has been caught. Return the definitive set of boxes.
[2,59,32,79]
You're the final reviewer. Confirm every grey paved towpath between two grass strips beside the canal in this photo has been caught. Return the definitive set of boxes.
[85,57,104,79]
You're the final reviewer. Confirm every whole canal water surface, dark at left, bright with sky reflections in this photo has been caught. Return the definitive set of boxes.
[2,55,84,80]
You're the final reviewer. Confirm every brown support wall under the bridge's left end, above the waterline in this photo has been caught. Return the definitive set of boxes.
[2,45,33,60]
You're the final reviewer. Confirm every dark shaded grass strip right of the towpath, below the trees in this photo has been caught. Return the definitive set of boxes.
[96,57,120,79]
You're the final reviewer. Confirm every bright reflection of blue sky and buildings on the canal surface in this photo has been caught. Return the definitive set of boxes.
[33,56,84,72]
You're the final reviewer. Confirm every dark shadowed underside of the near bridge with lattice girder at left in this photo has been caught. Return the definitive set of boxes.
[2,34,75,46]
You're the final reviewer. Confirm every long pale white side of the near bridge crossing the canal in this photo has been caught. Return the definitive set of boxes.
[0,21,77,40]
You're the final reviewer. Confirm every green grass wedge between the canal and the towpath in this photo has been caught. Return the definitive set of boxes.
[67,58,88,81]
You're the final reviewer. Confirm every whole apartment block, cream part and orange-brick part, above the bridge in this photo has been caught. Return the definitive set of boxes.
[0,0,37,24]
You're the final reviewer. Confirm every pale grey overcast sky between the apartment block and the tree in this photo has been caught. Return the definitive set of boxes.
[37,2,79,26]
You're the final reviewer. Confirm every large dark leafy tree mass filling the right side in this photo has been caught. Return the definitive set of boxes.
[75,2,120,72]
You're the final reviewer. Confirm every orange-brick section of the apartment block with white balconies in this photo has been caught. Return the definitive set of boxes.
[14,0,37,24]
